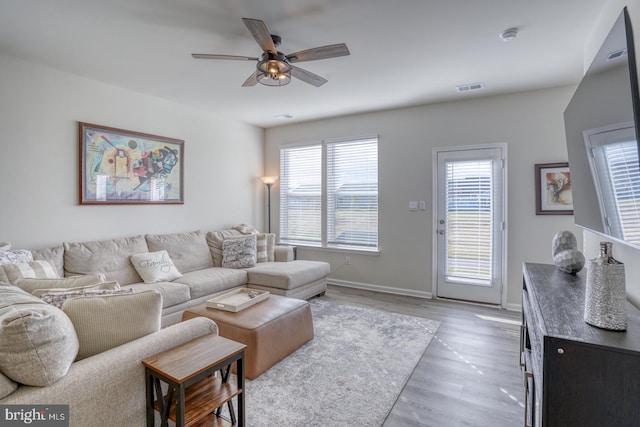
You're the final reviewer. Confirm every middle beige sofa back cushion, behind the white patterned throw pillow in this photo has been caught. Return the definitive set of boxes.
[146,230,213,274]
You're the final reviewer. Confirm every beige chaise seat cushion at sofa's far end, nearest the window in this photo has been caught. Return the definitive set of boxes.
[246,260,331,289]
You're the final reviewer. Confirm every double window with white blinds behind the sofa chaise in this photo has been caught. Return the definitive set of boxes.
[280,137,378,250]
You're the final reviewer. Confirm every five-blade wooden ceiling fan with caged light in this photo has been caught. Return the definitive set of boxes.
[191,18,349,87]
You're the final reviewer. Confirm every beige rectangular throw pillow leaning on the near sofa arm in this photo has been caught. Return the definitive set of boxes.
[62,291,162,360]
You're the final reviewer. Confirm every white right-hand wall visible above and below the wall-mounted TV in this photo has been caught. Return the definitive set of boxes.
[584,0,640,307]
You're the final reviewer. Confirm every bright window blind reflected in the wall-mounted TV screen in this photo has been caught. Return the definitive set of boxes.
[602,141,640,243]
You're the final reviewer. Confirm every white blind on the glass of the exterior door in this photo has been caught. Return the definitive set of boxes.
[446,160,494,285]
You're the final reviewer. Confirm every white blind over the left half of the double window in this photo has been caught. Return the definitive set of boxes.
[280,144,322,245]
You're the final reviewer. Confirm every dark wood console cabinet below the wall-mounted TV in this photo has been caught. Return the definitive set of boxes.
[520,263,640,427]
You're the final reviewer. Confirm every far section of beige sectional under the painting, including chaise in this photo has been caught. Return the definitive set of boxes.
[11,229,330,327]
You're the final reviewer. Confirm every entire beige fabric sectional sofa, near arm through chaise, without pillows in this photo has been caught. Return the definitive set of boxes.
[0,229,329,426]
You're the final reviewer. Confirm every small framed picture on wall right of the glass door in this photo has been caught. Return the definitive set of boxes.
[535,162,573,215]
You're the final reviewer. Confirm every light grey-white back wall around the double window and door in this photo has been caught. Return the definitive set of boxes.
[265,87,582,308]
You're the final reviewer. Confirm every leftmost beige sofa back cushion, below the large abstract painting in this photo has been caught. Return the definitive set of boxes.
[64,236,149,285]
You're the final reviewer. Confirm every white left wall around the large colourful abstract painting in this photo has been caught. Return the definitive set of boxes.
[0,56,265,248]
